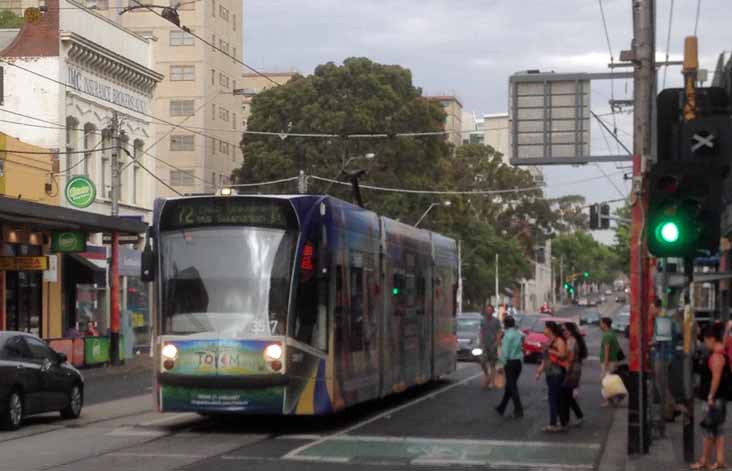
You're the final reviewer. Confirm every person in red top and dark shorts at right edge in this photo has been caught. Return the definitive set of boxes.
[691,322,732,469]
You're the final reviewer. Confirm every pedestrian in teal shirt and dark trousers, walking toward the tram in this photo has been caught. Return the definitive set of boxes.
[496,316,524,419]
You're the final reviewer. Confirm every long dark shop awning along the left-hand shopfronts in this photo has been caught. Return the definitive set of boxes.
[0,196,147,234]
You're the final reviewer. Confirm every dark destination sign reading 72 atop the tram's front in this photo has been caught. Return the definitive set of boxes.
[160,197,297,230]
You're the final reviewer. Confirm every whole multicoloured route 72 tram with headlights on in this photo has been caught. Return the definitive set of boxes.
[142,194,459,415]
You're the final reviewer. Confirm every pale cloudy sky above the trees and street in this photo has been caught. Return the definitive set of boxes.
[243,0,732,243]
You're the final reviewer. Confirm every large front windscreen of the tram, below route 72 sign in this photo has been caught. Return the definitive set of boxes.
[159,200,298,338]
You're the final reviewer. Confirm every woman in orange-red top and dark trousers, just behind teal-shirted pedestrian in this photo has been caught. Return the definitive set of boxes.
[536,321,569,432]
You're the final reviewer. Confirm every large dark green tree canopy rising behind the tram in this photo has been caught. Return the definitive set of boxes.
[234,58,600,305]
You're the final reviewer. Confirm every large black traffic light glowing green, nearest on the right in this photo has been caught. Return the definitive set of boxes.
[647,161,726,257]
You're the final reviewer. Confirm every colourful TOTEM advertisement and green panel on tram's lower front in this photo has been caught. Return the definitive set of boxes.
[161,339,284,413]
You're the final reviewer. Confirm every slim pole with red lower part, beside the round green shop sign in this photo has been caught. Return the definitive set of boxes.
[109,111,122,365]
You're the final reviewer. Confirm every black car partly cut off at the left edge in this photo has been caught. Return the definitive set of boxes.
[0,331,84,430]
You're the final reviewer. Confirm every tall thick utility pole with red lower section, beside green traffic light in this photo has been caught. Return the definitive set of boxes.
[621,0,656,454]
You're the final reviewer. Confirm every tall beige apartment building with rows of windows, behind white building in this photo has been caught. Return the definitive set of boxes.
[101,0,244,196]
